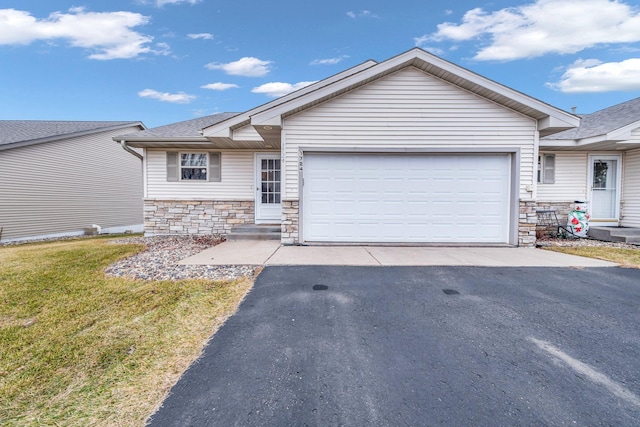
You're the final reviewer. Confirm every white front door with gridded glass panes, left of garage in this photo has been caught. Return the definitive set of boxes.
[256,154,282,224]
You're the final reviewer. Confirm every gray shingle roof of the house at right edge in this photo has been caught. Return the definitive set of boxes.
[542,98,640,139]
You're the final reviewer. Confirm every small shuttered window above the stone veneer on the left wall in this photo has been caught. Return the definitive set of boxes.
[167,151,220,181]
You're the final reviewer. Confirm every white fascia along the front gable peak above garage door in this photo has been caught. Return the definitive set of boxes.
[251,48,580,128]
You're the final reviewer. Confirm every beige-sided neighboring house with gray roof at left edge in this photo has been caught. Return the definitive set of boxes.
[0,120,145,242]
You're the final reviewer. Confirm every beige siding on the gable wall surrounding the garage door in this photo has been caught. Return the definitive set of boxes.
[283,68,536,200]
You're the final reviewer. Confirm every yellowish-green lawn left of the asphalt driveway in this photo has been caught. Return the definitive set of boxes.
[0,239,252,426]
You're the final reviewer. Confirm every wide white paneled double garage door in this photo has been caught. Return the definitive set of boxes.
[302,153,511,243]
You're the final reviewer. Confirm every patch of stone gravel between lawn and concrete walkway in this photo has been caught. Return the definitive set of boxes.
[105,236,257,280]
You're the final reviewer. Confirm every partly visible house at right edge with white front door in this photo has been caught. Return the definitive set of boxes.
[537,98,640,227]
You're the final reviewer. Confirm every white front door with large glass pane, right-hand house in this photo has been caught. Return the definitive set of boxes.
[589,155,622,226]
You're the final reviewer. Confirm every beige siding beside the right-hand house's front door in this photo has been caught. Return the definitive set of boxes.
[536,151,589,202]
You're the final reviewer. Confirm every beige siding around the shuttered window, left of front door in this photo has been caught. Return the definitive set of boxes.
[145,149,255,200]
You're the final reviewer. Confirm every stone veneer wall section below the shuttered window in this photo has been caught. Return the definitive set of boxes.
[144,199,255,235]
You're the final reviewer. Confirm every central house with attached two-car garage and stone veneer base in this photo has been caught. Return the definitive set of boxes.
[114,48,580,246]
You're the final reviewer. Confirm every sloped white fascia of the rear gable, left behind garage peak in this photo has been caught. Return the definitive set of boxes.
[203,60,377,136]
